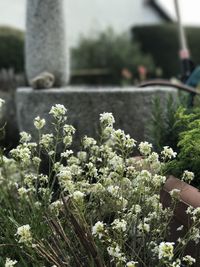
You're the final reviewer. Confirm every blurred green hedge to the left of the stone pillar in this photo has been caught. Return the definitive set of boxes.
[0,26,24,73]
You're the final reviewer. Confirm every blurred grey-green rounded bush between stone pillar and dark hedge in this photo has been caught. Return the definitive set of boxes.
[72,29,154,84]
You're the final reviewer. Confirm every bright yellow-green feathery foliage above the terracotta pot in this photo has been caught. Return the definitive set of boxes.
[167,108,200,187]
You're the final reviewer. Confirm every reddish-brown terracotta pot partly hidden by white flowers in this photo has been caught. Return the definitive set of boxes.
[160,176,200,267]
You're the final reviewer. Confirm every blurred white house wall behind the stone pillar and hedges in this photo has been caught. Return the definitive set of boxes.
[0,0,161,45]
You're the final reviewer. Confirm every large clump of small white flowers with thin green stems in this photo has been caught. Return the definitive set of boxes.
[0,105,200,267]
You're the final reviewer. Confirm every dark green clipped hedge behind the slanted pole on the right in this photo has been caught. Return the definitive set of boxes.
[132,24,200,78]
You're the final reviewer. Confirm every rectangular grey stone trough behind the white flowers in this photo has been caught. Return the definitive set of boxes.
[16,87,177,150]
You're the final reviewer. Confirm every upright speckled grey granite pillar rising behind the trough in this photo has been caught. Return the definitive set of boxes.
[25,0,69,87]
